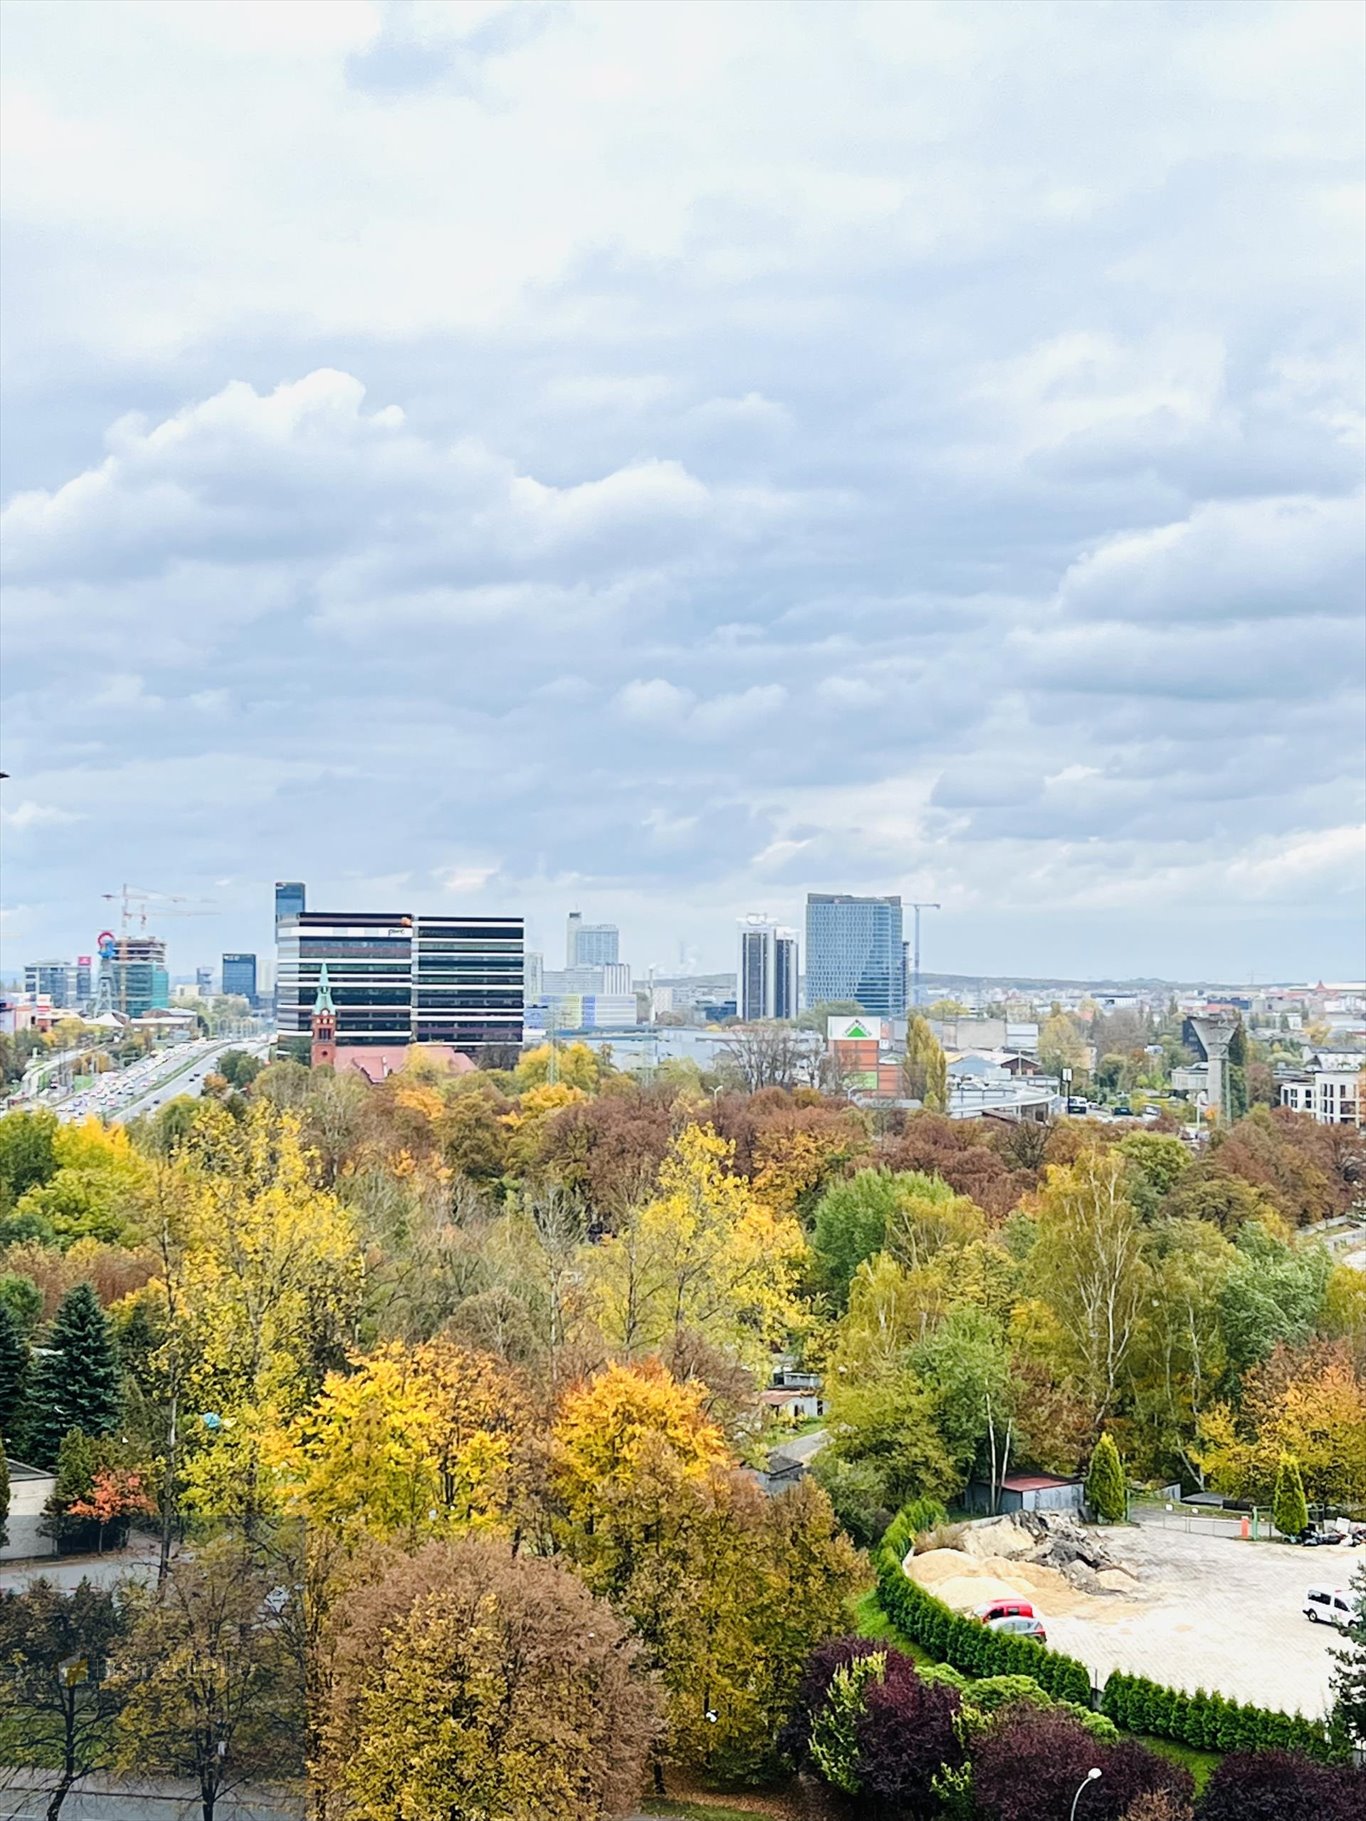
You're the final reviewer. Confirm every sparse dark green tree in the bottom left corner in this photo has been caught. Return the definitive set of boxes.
[0,1577,127,1821]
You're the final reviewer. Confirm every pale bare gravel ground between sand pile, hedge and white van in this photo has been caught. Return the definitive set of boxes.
[1045,1524,1362,1715]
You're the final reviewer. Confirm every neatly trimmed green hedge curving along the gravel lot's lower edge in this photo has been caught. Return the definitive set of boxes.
[876,1519,1342,1763]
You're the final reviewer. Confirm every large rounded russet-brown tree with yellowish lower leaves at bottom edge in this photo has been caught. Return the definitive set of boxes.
[321,1539,656,1821]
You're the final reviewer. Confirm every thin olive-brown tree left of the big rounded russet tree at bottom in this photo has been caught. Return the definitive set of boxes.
[109,1537,302,1821]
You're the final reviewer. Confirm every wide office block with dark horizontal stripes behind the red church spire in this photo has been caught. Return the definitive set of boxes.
[275,911,523,1062]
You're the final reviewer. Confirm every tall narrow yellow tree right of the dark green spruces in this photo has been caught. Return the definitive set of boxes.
[166,1102,362,1531]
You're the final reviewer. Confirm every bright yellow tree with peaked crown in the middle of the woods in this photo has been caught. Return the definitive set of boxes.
[588,1125,807,1369]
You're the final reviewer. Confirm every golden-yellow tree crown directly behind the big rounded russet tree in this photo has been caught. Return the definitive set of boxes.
[270,1338,530,1546]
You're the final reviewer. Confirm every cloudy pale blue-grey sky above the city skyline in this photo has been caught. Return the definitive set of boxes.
[0,0,1366,982]
